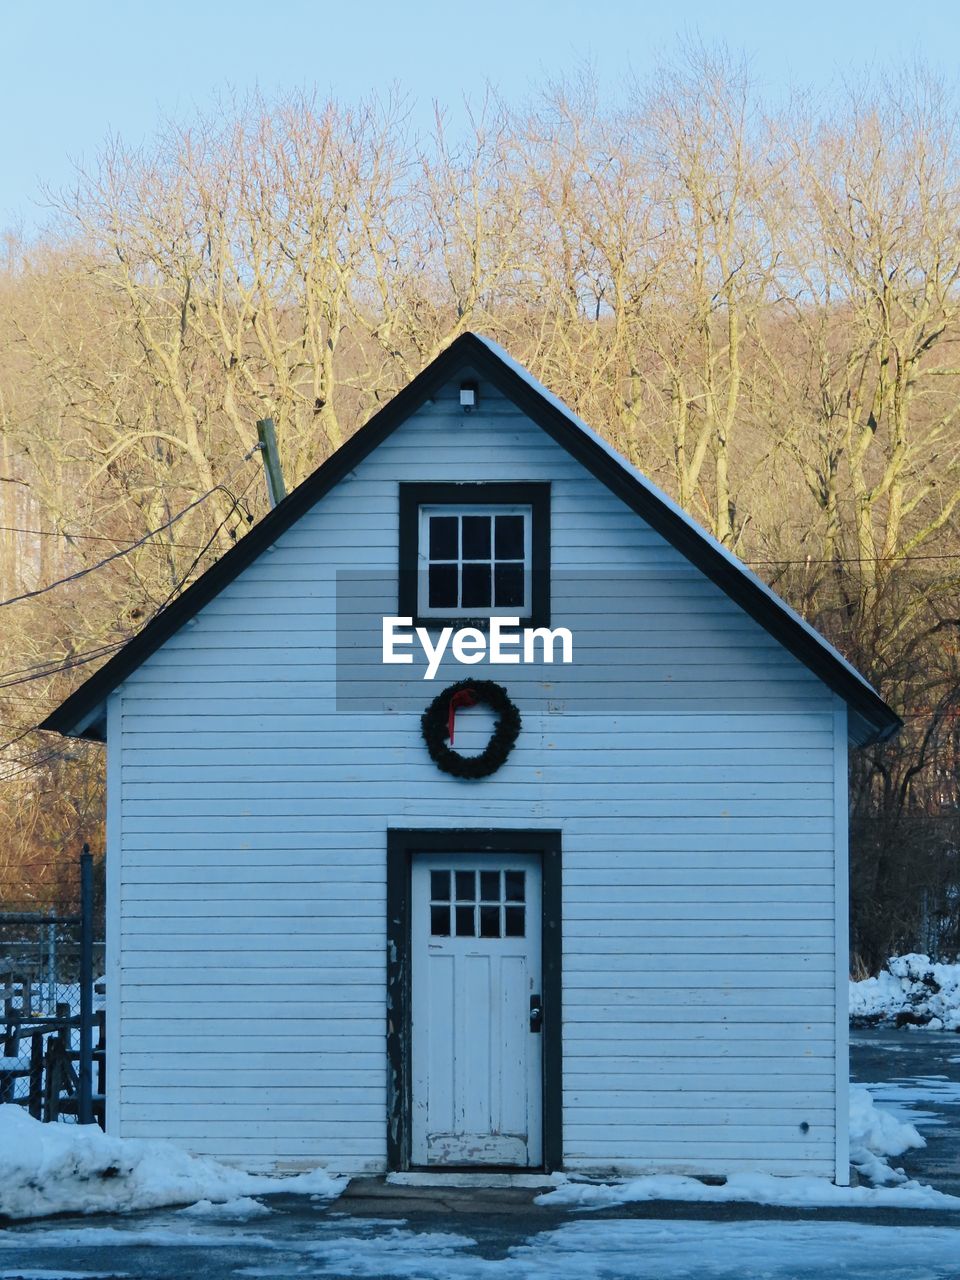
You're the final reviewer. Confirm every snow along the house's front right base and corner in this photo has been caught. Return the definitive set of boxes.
[536,1085,960,1210]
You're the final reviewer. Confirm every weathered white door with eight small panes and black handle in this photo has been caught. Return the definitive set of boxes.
[411,854,543,1167]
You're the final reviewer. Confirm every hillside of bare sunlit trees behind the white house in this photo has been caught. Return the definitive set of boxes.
[0,52,960,969]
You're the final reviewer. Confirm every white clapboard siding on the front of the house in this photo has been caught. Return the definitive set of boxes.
[110,368,837,1175]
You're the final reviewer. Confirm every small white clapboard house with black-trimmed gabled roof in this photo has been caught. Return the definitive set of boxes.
[44,334,900,1183]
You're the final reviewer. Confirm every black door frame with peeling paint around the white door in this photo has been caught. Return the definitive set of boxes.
[387,827,563,1174]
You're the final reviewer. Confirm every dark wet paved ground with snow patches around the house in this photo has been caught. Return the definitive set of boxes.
[0,1032,960,1280]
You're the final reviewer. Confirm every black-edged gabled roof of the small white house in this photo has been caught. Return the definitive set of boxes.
[40,333,902,745]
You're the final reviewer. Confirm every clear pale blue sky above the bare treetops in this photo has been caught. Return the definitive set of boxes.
[0,0,960,230]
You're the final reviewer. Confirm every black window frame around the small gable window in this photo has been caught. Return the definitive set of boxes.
[397,480,550,631]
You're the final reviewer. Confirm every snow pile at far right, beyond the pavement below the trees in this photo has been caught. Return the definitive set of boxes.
[850,952,960,1032]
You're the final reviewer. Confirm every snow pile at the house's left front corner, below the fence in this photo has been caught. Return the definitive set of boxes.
[0,1103,347,1217]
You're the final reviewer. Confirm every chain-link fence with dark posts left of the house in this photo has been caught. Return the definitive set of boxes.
[0,847,106,1124]
